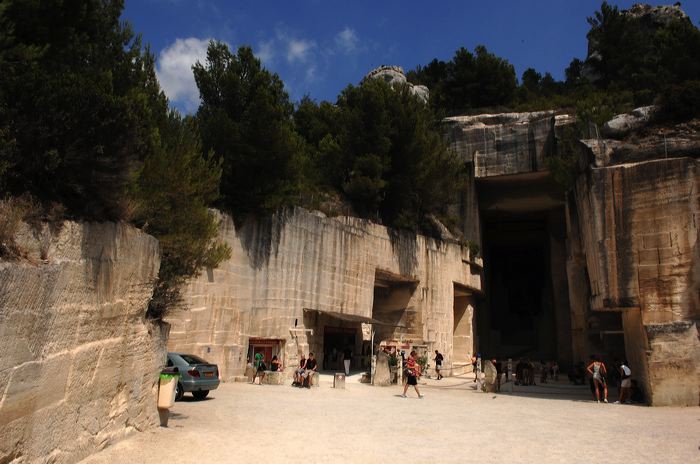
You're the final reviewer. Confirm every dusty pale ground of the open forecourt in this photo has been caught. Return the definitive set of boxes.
[84,376,700,464]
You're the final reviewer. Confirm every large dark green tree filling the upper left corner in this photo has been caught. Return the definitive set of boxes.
[0,0,167,219]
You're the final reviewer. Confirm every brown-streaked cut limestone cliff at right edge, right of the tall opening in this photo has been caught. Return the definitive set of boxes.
[568,122,700,405]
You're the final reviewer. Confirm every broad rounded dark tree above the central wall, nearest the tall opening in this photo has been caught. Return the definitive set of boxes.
[295,79,462,232]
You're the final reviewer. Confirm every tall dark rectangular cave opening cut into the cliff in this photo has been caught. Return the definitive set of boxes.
[476,173,573,367]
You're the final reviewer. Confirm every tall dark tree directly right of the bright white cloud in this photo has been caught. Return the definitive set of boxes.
[193,42,304,213]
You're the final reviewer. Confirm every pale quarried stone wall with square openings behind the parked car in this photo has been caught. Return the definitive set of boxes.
[168,209,481,380]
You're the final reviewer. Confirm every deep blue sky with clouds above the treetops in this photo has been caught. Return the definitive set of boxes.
[123,0,700,112]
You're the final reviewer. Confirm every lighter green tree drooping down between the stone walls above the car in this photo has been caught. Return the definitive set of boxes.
[132,112,230,318]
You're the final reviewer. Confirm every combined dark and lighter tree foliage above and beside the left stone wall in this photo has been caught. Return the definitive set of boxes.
[0,0,228,317]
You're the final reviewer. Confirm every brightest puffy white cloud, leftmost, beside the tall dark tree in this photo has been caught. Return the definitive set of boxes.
[156,37,211,112]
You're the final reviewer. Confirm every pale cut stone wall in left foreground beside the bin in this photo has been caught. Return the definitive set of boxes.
[0,222,165,463]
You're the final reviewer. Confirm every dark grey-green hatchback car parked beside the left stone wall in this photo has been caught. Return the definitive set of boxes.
[168,353,220,400]
